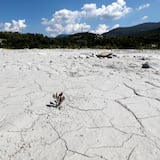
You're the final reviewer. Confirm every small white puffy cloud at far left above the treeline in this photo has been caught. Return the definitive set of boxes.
[0,19,27,32]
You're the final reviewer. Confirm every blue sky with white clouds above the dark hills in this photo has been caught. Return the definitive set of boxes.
[0,0,160,37]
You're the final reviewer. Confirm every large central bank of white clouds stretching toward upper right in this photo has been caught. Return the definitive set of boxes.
[42,0,132,36]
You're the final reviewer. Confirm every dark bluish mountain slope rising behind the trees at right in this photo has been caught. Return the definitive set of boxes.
[102,22,160,37]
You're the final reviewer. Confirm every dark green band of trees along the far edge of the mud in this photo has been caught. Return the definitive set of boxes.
[0,28,160,49]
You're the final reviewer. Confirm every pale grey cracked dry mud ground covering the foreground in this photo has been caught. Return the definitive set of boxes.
[0,49,160,160]
